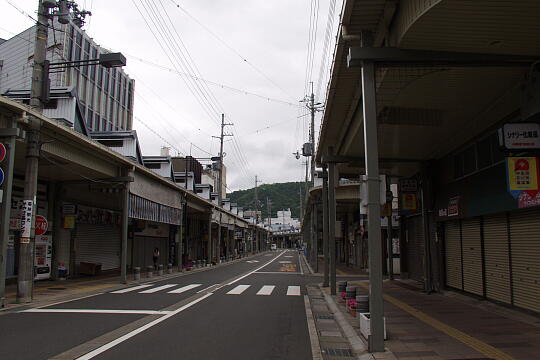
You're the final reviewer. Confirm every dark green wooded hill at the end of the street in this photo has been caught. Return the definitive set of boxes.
[227,182,305,218]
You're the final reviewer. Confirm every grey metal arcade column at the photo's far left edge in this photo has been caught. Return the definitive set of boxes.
[0,119,17,308]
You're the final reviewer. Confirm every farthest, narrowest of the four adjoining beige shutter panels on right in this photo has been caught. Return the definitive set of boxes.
[444,220,463,289]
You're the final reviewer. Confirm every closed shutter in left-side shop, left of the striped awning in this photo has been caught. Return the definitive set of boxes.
[75,224,120,270]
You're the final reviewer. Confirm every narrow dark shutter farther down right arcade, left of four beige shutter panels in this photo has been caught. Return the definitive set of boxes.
[407,216,424,281]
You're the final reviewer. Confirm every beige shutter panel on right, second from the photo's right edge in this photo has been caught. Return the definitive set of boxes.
[484,214,512,304]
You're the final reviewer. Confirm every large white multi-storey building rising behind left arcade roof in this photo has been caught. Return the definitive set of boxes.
[0,14,135,131]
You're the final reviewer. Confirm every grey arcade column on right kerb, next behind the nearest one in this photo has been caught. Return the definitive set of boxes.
[328,149,336,295]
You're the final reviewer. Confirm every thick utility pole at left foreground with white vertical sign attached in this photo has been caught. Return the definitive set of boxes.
[17,0,49,303]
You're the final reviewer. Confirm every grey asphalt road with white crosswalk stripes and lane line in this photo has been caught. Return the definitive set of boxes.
[0,251,312,360]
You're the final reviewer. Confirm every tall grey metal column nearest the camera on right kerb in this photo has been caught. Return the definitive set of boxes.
[361,40,384,352]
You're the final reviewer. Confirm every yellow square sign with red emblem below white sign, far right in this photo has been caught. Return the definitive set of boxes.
[507,157,538,191]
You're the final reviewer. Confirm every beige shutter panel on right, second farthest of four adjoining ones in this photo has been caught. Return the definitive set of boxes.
[461,218,484,296]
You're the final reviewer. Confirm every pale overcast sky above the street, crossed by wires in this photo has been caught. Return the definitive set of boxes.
[0,0,342,191]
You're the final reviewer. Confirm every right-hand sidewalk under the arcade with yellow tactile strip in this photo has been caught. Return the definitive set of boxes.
[308,258,540,360]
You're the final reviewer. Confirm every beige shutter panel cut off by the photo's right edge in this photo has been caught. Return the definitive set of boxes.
[510,210,540,312]
